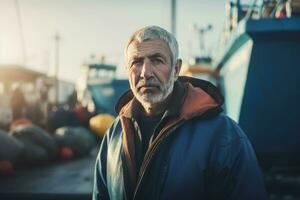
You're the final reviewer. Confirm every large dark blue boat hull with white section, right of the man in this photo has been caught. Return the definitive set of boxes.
[214,0,300,199]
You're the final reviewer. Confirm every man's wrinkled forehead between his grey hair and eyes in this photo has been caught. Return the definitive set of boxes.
[126,39,171,61]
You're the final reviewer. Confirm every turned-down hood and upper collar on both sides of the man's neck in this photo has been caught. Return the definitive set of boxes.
[115,76,224,119]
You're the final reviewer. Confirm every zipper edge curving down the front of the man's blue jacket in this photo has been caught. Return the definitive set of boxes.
[133,119,184,199]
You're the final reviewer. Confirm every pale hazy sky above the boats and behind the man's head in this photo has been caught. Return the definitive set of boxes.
[0,0,226,82]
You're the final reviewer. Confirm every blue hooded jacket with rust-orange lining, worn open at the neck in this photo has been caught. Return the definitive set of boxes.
[93,78,267,200]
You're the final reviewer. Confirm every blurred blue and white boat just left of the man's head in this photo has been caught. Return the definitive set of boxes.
[76,63,129,116]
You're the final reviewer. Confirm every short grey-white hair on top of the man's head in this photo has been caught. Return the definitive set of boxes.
[125,26,178,66]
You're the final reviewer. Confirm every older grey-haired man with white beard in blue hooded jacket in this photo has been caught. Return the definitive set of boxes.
[93,26,266,200]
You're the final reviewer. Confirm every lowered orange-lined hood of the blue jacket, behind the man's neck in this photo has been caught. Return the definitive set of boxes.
[115,76,224,119]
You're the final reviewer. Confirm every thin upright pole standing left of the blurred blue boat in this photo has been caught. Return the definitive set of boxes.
[54,33,61,105]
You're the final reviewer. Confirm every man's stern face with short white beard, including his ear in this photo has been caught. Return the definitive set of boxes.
[127,40,178,105]
